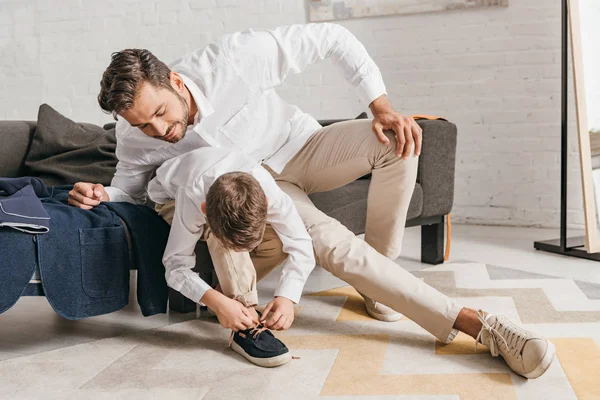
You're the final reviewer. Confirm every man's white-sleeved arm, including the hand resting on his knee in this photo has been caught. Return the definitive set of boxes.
[225,23,422,159]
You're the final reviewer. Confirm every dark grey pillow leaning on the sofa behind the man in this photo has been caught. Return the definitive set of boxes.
[23,104,117,186]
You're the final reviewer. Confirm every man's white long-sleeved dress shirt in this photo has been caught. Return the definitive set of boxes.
[106,23,386,203]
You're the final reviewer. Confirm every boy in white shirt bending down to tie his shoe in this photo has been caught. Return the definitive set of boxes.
[148,148,315,367]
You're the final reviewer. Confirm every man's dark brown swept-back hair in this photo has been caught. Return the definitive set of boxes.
[98,49,174,119]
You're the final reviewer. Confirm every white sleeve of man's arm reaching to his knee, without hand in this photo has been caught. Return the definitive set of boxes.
[226,23,386,105]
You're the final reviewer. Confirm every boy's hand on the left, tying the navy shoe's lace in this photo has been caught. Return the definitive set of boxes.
[200,289,258,331]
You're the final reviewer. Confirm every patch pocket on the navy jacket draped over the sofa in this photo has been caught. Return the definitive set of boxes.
[79,226,129,298]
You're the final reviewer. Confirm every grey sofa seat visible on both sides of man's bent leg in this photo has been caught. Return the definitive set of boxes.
[309,179,423,235]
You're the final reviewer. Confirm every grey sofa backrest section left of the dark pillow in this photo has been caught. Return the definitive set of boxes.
[0,121,36,178]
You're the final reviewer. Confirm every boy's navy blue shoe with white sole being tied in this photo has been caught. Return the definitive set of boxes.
[229,324,292,367]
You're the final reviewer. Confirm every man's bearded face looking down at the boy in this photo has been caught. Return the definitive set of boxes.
[121,84,189,143]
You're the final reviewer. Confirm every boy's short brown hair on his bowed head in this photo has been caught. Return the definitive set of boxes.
[206,172,268,251]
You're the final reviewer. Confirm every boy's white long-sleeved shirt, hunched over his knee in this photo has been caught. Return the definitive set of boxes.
[148,147,315,303]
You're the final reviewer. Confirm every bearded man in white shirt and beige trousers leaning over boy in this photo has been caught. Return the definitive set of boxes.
[69,24,554,378]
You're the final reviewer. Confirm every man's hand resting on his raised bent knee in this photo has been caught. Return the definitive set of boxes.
[369,95,423,160]
